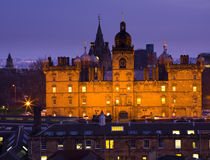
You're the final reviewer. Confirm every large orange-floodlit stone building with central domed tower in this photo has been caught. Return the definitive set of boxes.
[44,22,203,121]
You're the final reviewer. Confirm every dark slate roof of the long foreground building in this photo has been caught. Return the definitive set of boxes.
[38,122,210,136]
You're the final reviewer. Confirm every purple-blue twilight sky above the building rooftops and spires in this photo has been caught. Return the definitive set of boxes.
[0,0,210,59]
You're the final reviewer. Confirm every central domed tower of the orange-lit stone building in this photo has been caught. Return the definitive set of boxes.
[112,21,134,121]
